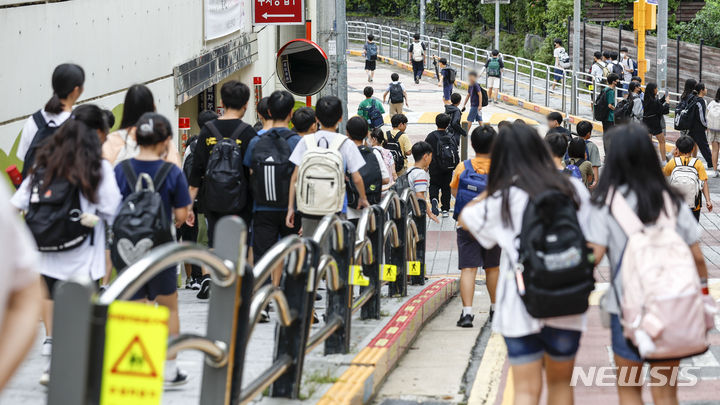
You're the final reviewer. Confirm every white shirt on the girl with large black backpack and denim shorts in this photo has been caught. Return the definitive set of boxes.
[460,179,590,337]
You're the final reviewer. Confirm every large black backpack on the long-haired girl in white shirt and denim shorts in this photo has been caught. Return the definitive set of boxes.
[518,190,595,318]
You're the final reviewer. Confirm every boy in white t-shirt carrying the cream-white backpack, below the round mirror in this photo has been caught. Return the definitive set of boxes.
[285,96,370,237]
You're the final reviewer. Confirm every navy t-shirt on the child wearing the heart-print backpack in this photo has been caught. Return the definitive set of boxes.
[115,159,192,220]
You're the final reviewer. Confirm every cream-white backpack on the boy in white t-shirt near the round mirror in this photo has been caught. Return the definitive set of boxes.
[295,134,347,216]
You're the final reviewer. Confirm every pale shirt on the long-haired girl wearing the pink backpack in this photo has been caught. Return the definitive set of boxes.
[584,185,700,315]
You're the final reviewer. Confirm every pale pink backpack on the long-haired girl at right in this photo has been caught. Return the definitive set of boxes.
[610,192,717,360]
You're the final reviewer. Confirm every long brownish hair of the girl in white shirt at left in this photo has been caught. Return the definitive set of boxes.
[31,120,102,203]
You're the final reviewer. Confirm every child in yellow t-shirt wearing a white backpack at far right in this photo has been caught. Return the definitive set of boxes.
[663,135,713,222]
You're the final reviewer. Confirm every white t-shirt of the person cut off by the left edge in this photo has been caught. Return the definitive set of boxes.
[0,184,39,330]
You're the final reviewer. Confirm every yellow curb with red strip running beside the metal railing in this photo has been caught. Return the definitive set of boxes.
[317,278,459,405]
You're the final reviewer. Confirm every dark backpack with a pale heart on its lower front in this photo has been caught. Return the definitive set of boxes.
[110,159,173,269]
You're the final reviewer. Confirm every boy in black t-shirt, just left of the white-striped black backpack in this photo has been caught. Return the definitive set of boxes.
[188,80,256,299]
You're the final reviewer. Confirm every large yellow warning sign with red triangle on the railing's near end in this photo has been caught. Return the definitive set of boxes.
[100,301,168,405]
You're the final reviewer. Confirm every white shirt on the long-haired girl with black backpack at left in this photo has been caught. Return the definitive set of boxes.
[10,160,122,280]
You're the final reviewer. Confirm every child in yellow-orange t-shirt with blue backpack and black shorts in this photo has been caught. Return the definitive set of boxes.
[450,125,500,328]
